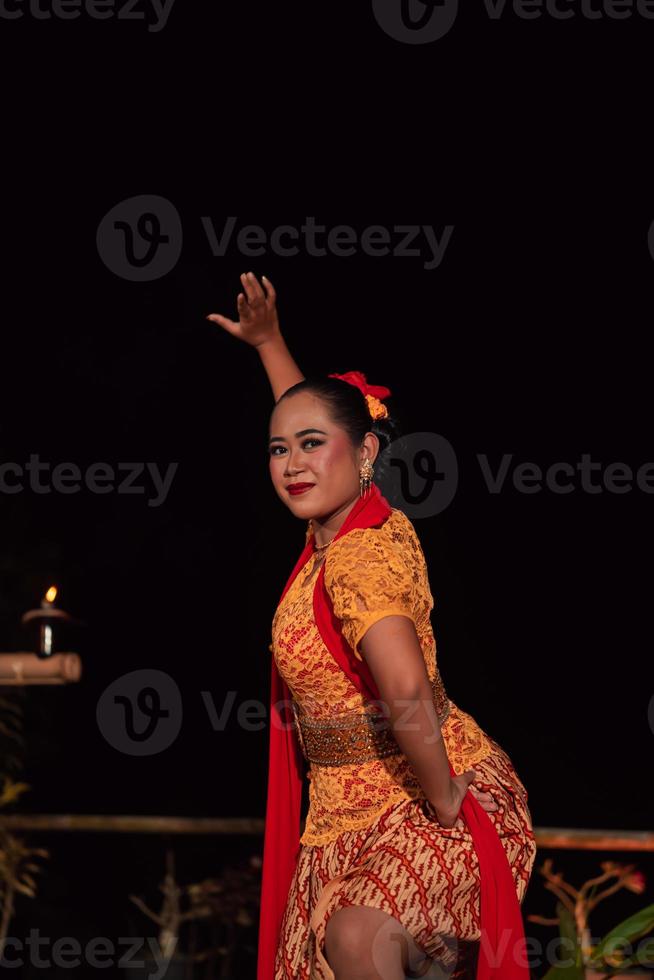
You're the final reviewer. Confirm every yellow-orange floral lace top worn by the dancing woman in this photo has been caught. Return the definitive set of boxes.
[271,507,492,844]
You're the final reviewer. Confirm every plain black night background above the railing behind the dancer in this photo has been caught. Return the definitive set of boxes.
[0,2,654,972]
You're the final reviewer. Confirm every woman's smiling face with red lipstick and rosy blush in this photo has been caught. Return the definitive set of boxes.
[269,391,377,520]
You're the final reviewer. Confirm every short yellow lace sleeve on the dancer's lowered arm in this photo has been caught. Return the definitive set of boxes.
[325,528,417,660]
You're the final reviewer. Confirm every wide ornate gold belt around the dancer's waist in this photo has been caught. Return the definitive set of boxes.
[292,682,450,766]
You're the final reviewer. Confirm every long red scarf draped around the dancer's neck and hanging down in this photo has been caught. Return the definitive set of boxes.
[257,483,530,980]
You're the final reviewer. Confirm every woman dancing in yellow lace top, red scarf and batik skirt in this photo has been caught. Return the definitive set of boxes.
[208,272,536,980]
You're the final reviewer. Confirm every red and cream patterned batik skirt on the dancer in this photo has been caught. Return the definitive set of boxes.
[275,739,536,980]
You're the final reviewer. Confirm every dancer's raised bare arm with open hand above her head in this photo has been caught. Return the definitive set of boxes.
[207,272,304,401]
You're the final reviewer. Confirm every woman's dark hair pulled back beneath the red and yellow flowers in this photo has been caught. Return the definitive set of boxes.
[277,375,401,482]
